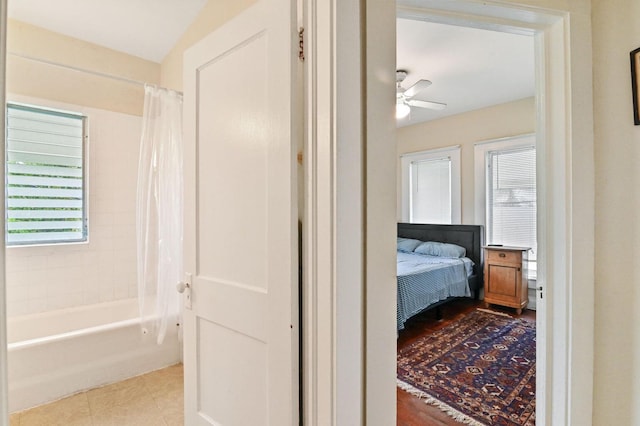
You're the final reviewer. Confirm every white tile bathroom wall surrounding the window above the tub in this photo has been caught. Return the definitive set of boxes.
[7,98,142,316]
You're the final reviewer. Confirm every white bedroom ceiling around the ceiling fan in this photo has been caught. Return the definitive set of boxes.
[397,19,535,127]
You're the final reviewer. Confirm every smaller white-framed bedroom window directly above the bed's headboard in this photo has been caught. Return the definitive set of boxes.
[401,146,461,224]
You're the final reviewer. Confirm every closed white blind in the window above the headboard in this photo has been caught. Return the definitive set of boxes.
[410,157,451,224]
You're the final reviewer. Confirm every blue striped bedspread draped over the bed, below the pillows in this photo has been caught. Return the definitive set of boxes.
[398,251,473,330]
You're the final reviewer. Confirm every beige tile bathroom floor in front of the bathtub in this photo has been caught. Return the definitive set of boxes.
[10,364,184,426]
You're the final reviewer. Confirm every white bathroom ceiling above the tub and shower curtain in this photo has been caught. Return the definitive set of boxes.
[9,0,207,62]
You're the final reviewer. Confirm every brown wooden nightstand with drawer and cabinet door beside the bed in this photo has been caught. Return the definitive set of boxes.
[484,246,529,315]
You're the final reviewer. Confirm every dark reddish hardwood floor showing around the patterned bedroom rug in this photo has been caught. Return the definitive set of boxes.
[397,299,536,426]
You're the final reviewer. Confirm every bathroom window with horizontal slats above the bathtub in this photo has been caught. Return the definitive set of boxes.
[6,104,87,245]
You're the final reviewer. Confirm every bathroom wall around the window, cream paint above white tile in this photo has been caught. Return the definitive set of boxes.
[6,21,154,316]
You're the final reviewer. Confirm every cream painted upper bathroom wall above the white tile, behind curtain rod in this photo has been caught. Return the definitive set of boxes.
[7,19,160,116]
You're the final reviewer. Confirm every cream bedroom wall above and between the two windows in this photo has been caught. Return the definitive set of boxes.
[397,97,536,224]
